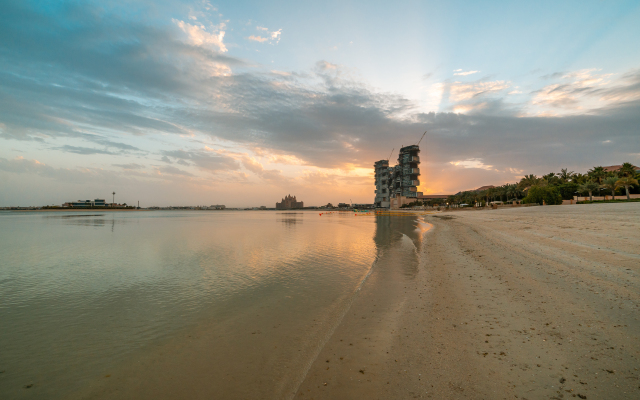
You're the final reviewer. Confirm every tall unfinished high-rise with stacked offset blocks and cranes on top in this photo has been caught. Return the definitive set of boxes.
[373,145,422,208]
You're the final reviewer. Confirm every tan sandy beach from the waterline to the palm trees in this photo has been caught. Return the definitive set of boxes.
[295,203,640,399]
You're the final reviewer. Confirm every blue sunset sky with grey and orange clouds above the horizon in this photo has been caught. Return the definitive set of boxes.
[0,0,640,207]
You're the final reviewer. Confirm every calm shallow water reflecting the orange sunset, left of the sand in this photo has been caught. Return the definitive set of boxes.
[0,211,419,398]
